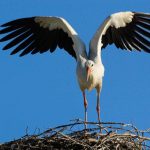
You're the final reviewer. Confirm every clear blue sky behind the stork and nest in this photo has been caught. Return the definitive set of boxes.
[0,0,150,142]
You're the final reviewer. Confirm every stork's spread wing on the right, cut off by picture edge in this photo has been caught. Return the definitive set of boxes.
[90,11,150,59]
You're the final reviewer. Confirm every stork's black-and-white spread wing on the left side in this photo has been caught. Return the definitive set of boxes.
[0,17,85,58]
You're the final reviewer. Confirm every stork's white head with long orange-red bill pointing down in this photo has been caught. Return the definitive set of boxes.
[85,60,94,81]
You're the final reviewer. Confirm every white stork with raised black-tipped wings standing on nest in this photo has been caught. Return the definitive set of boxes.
[0,11,150,126]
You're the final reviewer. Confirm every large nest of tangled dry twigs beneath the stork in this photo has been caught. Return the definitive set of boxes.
[0,120,150,150]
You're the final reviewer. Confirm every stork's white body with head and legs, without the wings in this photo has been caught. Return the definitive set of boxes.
[76,58,104,122]
